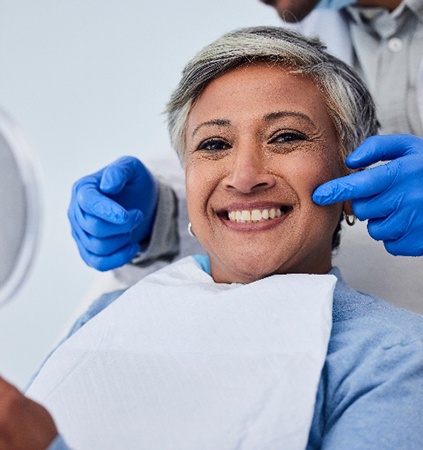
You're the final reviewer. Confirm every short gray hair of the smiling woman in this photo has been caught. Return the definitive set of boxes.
[166,27,378,167]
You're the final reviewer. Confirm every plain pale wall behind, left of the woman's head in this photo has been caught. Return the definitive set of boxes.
[0,0,280,387]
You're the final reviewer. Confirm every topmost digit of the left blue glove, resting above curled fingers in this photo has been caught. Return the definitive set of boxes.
[100,156,145,195]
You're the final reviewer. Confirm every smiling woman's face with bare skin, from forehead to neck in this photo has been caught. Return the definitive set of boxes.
[185,64,348,283]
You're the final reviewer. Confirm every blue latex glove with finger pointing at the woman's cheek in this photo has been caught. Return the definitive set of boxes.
[313,134,423,256]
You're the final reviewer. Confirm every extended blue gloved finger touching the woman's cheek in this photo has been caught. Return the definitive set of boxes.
[313,161,398,206]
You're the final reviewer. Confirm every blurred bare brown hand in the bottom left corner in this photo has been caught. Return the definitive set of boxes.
[0,378,58,450]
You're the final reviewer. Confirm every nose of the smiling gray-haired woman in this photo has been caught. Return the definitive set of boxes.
[223,146,275,194]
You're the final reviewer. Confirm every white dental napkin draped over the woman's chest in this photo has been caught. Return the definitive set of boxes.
[28,257,336,450]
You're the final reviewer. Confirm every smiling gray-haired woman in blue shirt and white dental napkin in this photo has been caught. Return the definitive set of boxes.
[4,28,423,449]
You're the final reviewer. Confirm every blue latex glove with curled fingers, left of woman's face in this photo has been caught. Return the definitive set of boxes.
[68,156,158,271]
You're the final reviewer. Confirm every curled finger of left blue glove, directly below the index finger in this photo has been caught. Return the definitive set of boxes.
[68,209,143,238]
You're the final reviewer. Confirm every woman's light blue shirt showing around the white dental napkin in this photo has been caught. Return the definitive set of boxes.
[45,255,423,450]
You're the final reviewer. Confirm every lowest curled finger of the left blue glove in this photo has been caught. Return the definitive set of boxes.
[72,230,140,272]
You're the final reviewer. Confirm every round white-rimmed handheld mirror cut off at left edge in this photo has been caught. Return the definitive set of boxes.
[0,109,40,305]
